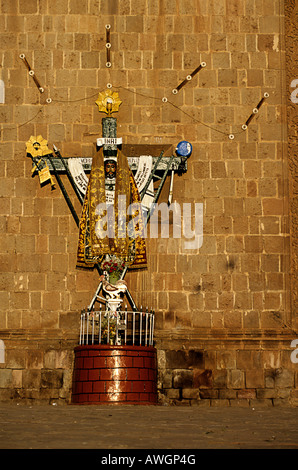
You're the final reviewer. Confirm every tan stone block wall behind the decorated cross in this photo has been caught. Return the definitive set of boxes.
[0,0,298,404]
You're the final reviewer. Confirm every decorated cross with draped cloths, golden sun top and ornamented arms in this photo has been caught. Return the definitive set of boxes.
[27,89,192,312]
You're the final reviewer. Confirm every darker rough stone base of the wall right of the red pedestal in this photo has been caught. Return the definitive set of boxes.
[158,341,297,406]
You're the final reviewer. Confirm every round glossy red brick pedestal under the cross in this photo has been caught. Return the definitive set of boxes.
[72,345,157,405]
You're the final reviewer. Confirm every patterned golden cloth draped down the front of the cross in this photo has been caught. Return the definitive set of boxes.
[77,149,147,268]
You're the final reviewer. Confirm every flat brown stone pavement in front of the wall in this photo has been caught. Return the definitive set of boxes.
[0,403,298,451]
